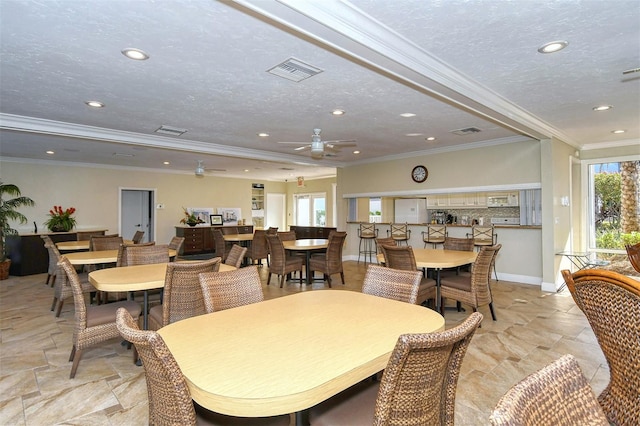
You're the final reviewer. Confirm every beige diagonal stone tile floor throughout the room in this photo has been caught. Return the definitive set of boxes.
[0,262,609,425]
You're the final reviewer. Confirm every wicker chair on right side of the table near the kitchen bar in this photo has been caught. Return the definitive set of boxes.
[440,244,501,321]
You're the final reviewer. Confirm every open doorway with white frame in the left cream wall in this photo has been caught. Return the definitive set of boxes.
[119,188,155,242]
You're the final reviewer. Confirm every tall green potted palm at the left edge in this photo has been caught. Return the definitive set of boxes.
[0,181,35,280]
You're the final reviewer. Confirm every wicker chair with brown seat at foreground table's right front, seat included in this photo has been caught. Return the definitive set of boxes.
[309,312,482,426]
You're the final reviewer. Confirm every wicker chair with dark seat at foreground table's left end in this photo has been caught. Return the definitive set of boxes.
[116,309,291,426]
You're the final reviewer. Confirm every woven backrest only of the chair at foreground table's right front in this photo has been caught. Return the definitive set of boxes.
[374,312,482,425]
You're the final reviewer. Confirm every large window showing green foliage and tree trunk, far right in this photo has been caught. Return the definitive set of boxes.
[587,160,640,253]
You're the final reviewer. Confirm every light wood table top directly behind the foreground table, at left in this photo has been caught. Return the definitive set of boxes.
[89,263,236,291]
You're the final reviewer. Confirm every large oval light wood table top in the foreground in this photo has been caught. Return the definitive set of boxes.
[159,290,444,417]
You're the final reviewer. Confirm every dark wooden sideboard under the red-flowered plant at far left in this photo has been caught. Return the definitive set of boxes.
[6,229,106,276]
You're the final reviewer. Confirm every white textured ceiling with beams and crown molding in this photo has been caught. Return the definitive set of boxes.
[0,0,640,180]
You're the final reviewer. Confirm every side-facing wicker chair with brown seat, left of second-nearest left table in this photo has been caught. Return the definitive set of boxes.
[58,256,142,379]
